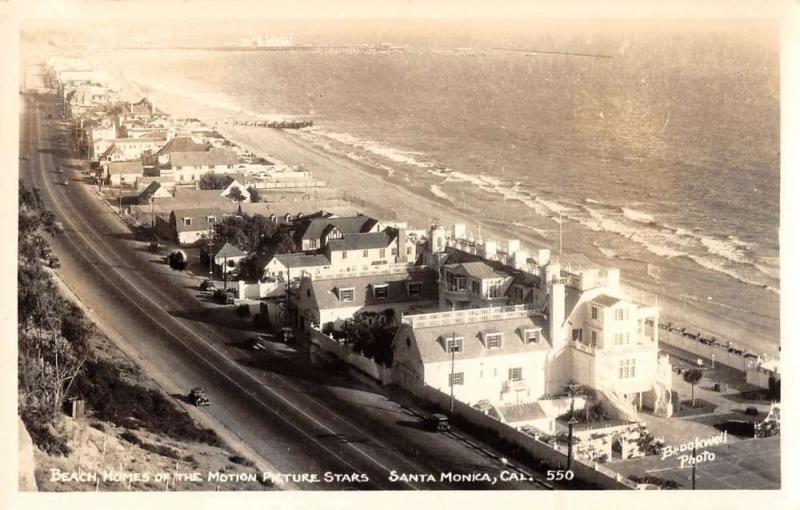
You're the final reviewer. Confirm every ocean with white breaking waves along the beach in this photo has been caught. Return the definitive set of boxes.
[97,20,780,352]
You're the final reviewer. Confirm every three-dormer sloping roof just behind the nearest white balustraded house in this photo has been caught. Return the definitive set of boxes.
[302,270,438,310]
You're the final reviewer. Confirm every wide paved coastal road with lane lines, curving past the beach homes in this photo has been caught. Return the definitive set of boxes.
[20,88,556,490]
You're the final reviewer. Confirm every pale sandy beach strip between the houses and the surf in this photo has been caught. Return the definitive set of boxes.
[97,60,780,357]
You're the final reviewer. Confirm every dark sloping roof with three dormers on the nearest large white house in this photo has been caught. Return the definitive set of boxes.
[403,315,550,363]
